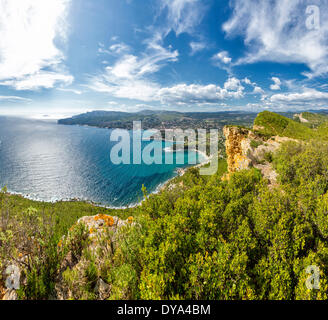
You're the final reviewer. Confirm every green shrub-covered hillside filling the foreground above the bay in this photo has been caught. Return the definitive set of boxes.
[0,113,328,300]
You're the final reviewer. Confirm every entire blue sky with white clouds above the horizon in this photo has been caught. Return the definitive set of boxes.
[0,0,328,118]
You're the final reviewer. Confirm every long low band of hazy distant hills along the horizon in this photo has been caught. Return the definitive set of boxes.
[58,110,328,131]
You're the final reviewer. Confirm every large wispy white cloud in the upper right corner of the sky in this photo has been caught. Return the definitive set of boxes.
[223,0,328,77]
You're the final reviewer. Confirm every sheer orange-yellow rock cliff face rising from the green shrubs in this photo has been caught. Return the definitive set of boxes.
[223,127,252,173]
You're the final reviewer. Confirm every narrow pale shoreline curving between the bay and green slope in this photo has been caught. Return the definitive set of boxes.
[1,150,212,210]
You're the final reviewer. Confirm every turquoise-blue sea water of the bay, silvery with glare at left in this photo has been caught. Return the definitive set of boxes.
[0,117,203,207]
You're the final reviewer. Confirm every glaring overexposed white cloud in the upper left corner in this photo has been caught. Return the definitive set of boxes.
[0,0,72,90]
